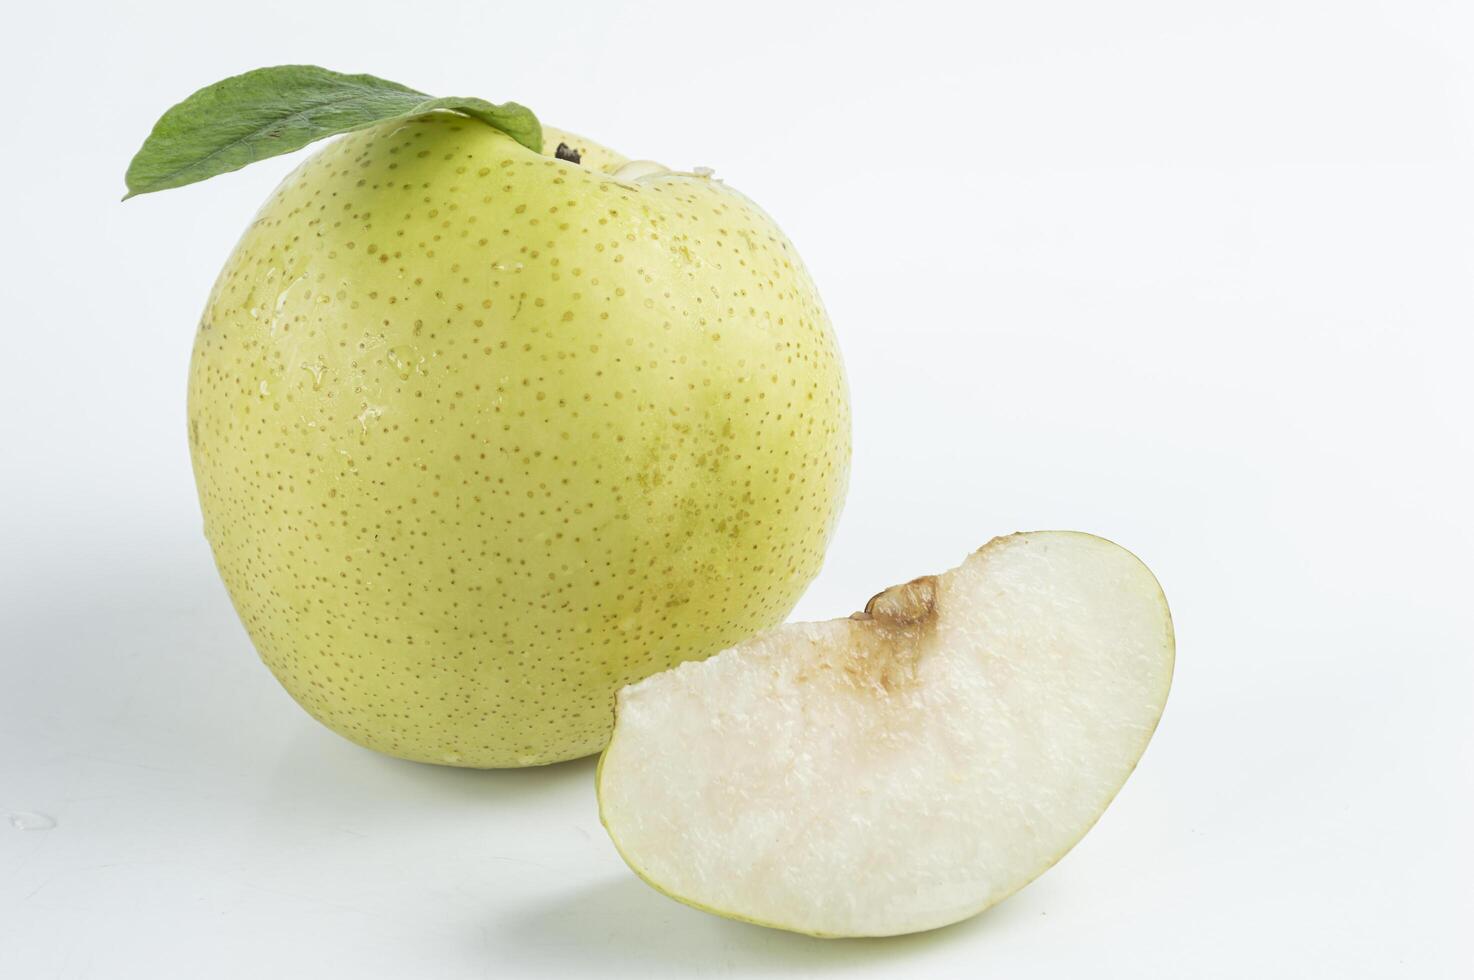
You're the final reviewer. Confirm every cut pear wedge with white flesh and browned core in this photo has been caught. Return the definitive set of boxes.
[597,531,1173,936]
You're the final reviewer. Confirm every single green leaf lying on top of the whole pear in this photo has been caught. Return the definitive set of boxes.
[124,65,542,200]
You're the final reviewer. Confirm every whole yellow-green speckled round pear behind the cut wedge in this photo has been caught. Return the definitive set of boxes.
[189,112,849,768]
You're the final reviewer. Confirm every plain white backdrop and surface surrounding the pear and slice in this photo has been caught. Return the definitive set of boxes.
[0,0,1474,980]
